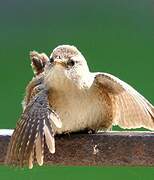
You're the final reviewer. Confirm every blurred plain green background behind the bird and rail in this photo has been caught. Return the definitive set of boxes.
[0,0,154,180]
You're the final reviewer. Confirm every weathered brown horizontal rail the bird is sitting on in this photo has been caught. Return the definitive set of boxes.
[0,130,154,166]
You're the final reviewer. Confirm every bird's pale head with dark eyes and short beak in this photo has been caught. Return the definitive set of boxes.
[47,45,90,87]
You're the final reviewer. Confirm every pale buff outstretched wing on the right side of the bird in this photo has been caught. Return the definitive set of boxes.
[94,73,154,130]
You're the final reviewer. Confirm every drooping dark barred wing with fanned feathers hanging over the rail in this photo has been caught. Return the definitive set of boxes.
[6,84,62,168]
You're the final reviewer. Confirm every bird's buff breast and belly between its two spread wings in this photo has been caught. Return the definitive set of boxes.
[49,85,112,134]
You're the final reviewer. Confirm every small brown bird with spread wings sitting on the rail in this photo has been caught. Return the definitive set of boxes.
[6,45,154,168]
